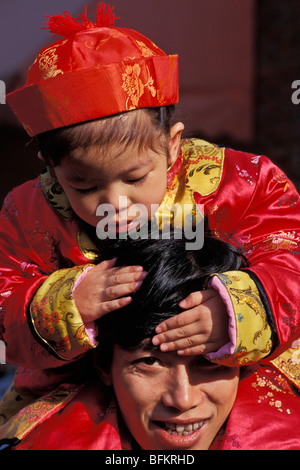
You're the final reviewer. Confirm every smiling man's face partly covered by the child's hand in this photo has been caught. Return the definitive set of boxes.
[110,340,239,450]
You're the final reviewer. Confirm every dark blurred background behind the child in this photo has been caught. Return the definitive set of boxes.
[0,0,300,394]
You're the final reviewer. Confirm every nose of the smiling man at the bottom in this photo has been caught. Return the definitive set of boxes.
[162,364,202,412]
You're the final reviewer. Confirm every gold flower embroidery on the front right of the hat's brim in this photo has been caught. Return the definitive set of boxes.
[122,64,156,110]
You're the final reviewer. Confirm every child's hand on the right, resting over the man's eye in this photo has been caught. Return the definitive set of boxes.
[152,289,229,355]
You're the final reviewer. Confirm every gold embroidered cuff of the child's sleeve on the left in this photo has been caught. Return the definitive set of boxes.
[30,265,95,361]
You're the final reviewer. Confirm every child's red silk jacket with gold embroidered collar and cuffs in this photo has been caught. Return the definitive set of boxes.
[0,139,300,402]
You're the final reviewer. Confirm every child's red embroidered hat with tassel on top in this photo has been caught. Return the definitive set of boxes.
[7,2,178,136]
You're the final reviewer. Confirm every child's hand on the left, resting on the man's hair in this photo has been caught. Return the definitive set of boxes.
[73,259,146,323]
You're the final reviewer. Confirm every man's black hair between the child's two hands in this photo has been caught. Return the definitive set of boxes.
[97,237,247,369]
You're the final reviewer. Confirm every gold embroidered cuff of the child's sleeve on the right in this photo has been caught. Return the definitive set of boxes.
[213,271,272,367]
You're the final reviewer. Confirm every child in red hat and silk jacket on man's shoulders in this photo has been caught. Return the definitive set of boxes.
[0,3,300,415]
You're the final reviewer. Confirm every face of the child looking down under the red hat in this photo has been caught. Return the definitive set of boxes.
[54,139,170,232]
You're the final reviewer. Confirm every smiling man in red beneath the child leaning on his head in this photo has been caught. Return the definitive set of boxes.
[1,238,300,451]
